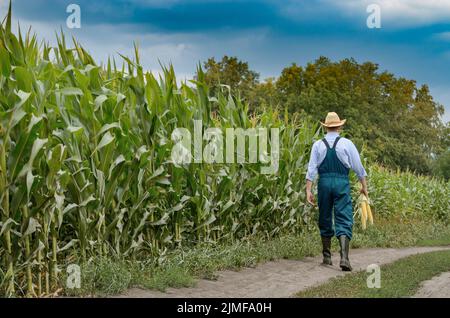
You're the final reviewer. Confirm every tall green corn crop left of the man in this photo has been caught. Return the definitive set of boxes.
[0,8,449,297]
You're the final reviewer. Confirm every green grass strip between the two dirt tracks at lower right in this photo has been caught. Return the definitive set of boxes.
[297,251,450,298]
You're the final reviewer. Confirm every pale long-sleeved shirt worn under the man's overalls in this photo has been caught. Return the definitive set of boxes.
[306,132,367,181]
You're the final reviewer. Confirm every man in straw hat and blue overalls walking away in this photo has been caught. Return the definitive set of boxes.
[306,112,368,271]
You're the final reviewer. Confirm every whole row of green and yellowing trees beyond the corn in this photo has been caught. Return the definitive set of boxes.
[203,56,450,179]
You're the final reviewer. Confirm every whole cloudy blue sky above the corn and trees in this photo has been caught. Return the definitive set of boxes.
[0,0,450,121]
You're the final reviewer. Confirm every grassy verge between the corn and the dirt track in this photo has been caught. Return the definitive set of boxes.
[64,220,450,296]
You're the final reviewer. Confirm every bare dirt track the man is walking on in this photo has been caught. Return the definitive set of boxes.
[118,247,450,298]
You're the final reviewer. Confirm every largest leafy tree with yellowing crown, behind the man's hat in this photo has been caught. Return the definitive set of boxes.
[277,57,443,173]
